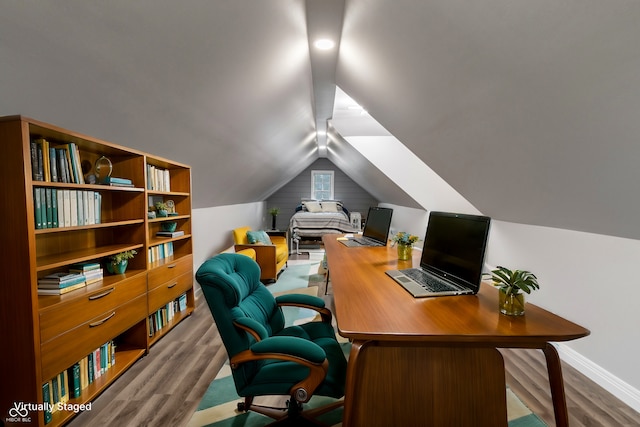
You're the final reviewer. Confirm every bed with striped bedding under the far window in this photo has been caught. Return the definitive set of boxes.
[289,200,354,243]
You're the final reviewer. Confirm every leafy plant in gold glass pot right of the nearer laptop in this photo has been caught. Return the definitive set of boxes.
[491,266,540,316]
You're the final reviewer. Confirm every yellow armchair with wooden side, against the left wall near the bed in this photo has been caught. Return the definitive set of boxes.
[233,227,289,282]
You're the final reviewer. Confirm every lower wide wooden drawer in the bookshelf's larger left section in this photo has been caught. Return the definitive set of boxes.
[40,295,147,379]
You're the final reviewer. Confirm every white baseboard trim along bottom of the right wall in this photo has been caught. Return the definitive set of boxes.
[556,344,640,412]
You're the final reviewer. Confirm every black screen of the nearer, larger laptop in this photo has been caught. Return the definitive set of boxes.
[420,212,491,290]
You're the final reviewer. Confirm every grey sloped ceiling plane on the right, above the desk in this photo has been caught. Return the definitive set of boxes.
[337,0,640,239]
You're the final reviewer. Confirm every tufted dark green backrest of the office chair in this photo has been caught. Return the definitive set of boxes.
[196,253,284,390]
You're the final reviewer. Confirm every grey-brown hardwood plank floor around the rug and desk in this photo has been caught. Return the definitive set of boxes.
[69,289,640,427]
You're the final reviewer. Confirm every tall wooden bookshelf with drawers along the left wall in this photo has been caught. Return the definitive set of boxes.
[0,116,195,426]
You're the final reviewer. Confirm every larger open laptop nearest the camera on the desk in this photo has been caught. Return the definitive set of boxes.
[386,212,491,298]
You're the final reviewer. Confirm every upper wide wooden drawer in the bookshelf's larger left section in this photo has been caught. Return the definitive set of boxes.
[40,274,147,343]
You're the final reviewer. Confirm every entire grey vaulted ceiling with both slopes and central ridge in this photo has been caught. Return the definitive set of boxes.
[0,0,640,239]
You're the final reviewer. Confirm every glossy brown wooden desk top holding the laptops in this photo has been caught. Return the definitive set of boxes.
[323,235,589,348]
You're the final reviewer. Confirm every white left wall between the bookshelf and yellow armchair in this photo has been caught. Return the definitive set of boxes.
[192,202,267,273]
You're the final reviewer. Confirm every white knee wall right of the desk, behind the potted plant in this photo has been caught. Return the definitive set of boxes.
[487,221,640,411]
